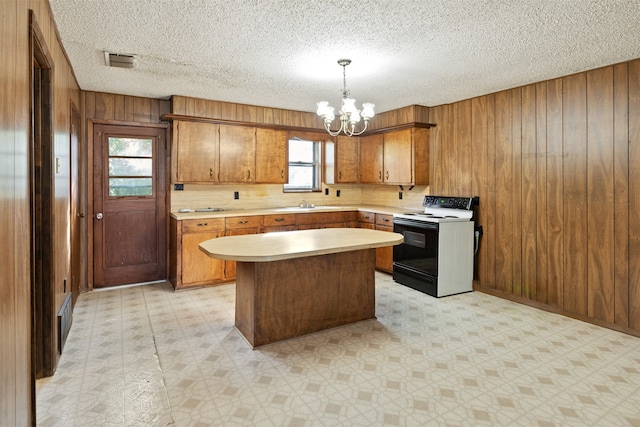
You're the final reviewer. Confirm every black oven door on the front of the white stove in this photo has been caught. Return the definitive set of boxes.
[393,218,438,278]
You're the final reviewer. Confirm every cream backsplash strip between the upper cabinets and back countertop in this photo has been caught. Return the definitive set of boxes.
[171,184,429,212]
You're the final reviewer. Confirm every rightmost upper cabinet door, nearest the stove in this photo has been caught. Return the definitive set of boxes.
[383,129,413,184]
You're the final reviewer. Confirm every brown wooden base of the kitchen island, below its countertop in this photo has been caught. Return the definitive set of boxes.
[235,249,375,347]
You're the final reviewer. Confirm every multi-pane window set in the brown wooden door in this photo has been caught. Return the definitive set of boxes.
[109,137,153,197]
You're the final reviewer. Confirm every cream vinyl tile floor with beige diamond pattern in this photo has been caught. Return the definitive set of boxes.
[37,273,640,426]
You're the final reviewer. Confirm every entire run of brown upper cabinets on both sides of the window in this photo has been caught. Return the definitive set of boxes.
[171,113,429,185]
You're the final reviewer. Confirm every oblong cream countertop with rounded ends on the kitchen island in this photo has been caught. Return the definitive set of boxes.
[200,228,403,262]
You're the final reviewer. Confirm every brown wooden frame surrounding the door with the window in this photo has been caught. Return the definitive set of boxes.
[85,119,171,291]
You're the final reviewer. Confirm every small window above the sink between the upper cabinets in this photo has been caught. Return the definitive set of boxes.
[284,138,321,192]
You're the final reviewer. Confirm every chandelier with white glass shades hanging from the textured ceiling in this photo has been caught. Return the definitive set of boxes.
[316,59,375,136]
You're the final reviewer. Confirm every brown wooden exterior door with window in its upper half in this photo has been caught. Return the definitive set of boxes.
[93,125,166,288]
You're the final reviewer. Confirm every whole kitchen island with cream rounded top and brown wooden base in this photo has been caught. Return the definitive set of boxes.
[200,228,403,347]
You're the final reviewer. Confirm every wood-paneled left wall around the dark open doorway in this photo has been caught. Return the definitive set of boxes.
[0,0,80,426]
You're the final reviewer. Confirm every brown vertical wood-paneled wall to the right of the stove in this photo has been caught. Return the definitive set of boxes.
[430,60,640,335]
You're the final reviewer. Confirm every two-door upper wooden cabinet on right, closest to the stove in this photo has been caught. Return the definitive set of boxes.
[360,128,429,185]
